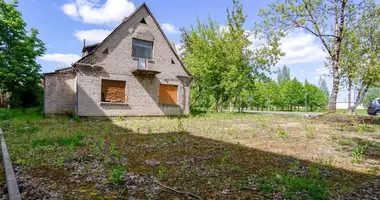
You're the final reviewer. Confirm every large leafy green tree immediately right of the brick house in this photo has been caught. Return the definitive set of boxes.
[181,0,282,112]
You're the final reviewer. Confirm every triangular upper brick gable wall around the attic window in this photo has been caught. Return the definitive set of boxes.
[80,6,189,79]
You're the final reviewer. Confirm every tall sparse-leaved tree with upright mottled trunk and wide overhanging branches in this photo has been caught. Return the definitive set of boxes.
[258,0,373,111]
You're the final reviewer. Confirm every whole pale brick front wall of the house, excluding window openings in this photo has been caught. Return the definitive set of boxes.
[77,7,190,116]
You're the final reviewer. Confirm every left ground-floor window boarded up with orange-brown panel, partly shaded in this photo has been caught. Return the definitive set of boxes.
[102,80,127,103]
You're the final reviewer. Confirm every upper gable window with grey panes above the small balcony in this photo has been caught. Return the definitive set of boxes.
[132,38,153,60]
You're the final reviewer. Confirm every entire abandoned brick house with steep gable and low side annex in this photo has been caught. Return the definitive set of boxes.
[44,3,192,116]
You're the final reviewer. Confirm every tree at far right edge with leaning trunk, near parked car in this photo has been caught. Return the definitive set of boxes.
[340,5,380,114]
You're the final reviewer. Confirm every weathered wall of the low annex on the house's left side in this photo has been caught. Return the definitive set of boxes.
[44,72,75,115]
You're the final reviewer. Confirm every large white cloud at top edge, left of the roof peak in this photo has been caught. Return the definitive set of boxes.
[62,0,135,25]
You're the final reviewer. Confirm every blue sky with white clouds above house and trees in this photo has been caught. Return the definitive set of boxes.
[14,0,368,101]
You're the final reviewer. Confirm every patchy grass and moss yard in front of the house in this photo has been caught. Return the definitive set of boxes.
[0,112,380,199]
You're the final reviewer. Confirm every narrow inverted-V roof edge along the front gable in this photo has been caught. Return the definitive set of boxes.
[73,2,191,76]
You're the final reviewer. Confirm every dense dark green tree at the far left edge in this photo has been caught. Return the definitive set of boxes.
[0,0,45,106]
